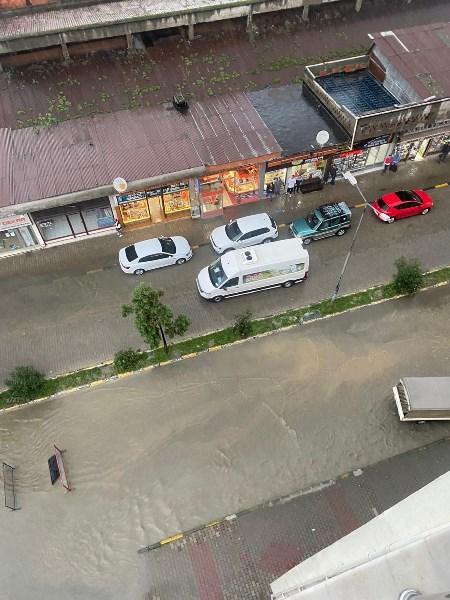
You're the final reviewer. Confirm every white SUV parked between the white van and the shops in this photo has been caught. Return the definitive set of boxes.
[209,213,278,254]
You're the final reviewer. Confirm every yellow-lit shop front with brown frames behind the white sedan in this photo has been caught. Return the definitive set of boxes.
[115,182,191,226]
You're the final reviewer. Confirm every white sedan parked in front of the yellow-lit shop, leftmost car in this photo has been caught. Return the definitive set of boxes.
[119,235,192,275]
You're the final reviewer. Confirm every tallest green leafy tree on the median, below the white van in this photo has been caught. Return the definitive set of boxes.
[122,283,190,353]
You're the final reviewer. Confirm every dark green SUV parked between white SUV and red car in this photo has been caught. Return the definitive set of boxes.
[290,202,352,245]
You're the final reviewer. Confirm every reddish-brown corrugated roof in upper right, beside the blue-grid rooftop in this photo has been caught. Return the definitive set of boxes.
[372,23,450,99]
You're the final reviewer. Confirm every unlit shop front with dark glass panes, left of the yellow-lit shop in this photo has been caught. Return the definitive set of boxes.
[31,198,114,244]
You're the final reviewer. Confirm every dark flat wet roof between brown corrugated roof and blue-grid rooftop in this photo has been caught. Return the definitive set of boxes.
[247,85,349,156]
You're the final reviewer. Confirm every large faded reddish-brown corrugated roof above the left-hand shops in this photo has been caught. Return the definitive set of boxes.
[0,93,281,207]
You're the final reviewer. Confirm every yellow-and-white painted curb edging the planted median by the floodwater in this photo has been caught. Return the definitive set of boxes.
[0,278,450,414]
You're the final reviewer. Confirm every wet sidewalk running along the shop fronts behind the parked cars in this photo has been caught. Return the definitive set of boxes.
[0,157,450,279]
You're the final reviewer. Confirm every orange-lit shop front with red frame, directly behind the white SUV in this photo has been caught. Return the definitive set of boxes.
[198,165,259,217]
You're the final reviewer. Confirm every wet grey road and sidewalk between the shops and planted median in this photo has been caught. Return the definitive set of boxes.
[0,158,450,386]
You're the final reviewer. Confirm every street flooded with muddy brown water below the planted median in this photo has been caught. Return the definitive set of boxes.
[0,286,450,600]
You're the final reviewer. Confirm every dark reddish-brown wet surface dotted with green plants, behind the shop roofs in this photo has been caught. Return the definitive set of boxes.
[0,0,450,127]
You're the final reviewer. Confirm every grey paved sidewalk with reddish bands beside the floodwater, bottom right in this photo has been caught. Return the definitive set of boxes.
[142,439,450,600]
